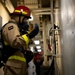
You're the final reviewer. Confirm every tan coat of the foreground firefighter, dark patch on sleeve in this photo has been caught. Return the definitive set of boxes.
[2,20,28,75]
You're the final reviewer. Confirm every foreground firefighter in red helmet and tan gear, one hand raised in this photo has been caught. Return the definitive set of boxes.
[2,6,39,75]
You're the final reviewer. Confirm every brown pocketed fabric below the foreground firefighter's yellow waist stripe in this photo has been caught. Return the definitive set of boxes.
[4,59,28,75]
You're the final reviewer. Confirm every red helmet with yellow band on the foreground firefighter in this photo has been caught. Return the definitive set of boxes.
[11,6,31,18]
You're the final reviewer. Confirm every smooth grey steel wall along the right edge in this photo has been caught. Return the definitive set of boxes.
[60,0,75,75]
